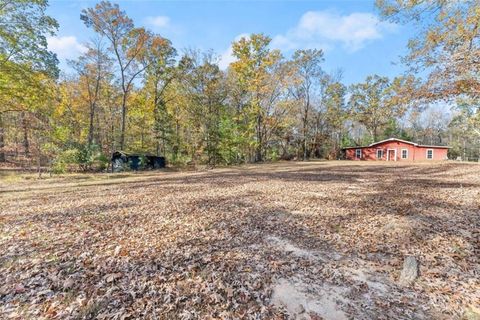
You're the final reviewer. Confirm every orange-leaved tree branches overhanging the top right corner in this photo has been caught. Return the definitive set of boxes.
[376,0,480,132]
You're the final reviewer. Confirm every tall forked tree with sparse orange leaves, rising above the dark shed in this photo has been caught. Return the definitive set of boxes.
[80,1,151,149]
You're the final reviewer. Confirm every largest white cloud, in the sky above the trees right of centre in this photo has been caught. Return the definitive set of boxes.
[272,11,397,52]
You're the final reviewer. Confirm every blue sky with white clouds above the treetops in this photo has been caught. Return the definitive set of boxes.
[44,0,412,84]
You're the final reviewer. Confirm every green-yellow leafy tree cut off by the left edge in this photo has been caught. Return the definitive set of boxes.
[0,0,58,162]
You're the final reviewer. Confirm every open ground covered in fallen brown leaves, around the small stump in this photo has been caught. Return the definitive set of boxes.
[0,162,480,319]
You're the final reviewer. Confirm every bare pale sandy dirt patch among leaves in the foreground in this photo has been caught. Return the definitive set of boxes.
[266,236,395,320]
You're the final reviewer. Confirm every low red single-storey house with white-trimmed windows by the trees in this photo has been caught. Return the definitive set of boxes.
[344,138,449,161]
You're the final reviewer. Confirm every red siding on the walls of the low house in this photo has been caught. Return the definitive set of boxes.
[346,141,448,161]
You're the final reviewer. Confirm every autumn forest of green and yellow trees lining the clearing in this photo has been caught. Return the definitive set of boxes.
[0,0,480,173]
